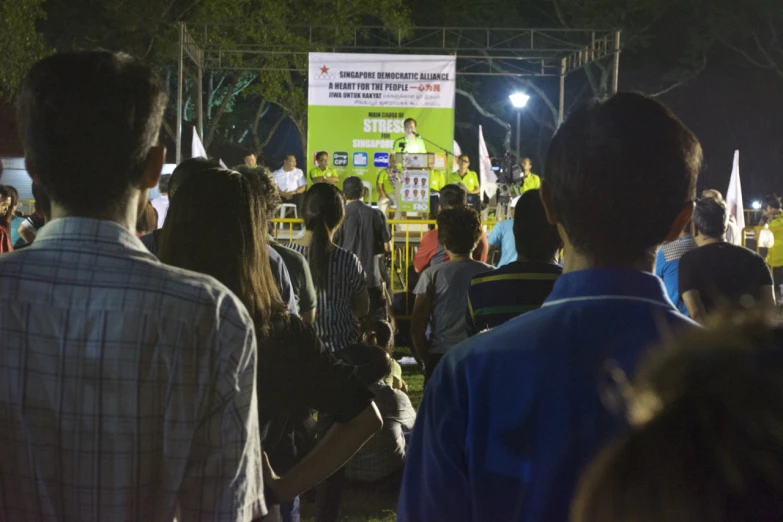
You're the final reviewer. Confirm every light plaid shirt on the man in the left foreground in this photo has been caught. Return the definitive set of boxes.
[0,218,266,522]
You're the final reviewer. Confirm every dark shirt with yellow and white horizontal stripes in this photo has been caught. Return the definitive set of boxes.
[466,261,563,335]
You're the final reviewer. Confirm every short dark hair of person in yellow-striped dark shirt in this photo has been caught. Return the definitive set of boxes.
[514,190,563,261]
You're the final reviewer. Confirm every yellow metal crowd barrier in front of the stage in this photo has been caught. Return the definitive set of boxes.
[272,218,497,319]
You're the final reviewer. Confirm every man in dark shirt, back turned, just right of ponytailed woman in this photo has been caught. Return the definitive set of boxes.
[334,176,392,321]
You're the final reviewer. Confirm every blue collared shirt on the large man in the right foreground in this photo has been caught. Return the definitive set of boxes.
[397,269,695,522]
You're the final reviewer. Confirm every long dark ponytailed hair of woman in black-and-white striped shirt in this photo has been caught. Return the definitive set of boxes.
[302,183,345,290]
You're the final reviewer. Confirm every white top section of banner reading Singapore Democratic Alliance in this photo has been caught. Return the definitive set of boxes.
[308,53,457,107]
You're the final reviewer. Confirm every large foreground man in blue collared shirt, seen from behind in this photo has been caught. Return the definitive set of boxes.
[397,93,702,522]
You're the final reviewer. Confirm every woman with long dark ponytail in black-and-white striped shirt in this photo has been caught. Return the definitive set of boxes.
[290,183,370,357]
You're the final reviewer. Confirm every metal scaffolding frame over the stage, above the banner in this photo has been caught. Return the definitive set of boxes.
[177,23,621,163]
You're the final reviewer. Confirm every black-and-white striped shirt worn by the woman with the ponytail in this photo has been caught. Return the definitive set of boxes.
[287,243,367,352]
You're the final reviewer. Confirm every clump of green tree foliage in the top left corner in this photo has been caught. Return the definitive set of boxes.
[0,0,47,100]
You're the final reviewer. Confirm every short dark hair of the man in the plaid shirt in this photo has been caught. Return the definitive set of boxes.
[16,51,167,216]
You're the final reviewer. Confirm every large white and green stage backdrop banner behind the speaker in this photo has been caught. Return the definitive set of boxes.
[307,53,456,201]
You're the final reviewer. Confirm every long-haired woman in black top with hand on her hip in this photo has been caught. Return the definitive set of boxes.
[158,169,381,520]
